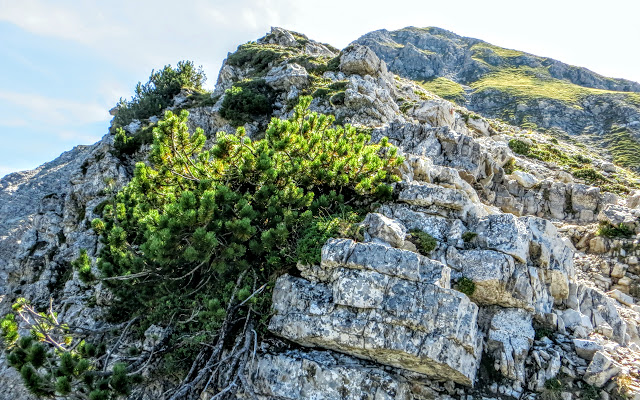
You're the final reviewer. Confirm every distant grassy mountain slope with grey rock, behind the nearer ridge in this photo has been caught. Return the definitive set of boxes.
[355,27,640,169]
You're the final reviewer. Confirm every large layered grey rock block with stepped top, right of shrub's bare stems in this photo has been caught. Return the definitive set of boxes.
[269,239,482,385]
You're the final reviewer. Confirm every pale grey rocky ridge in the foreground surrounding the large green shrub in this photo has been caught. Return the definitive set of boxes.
[0,28,640,399]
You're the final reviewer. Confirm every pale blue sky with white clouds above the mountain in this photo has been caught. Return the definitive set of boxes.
[0,0,640,176]
